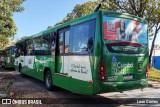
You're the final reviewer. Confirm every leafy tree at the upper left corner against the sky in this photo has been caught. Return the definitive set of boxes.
[0,0,25,48]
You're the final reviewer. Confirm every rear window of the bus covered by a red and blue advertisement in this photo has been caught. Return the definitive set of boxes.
[103,15,148,45]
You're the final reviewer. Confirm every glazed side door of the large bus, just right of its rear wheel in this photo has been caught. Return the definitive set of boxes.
[54,29,69,89]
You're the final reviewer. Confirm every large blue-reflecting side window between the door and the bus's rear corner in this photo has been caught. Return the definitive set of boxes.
[69,20,95,54]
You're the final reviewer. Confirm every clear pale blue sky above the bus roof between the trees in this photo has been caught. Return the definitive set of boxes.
[13,0,87,40]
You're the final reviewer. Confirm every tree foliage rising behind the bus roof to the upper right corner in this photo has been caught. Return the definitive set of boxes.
[56,0,160,36]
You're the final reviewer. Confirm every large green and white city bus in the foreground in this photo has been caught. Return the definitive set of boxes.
[15,10,149,94]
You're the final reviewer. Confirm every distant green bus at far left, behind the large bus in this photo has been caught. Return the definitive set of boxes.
[1,45,15,69]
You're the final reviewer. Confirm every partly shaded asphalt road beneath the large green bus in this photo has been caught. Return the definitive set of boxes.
[0,68,160,107]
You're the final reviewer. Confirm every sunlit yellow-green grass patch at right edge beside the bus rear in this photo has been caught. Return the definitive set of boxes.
[148,67,160,81]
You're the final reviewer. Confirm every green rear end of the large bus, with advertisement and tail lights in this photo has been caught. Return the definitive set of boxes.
[96,11,149,93]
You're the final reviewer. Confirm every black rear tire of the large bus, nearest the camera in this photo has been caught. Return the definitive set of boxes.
[45,71,55,91]
